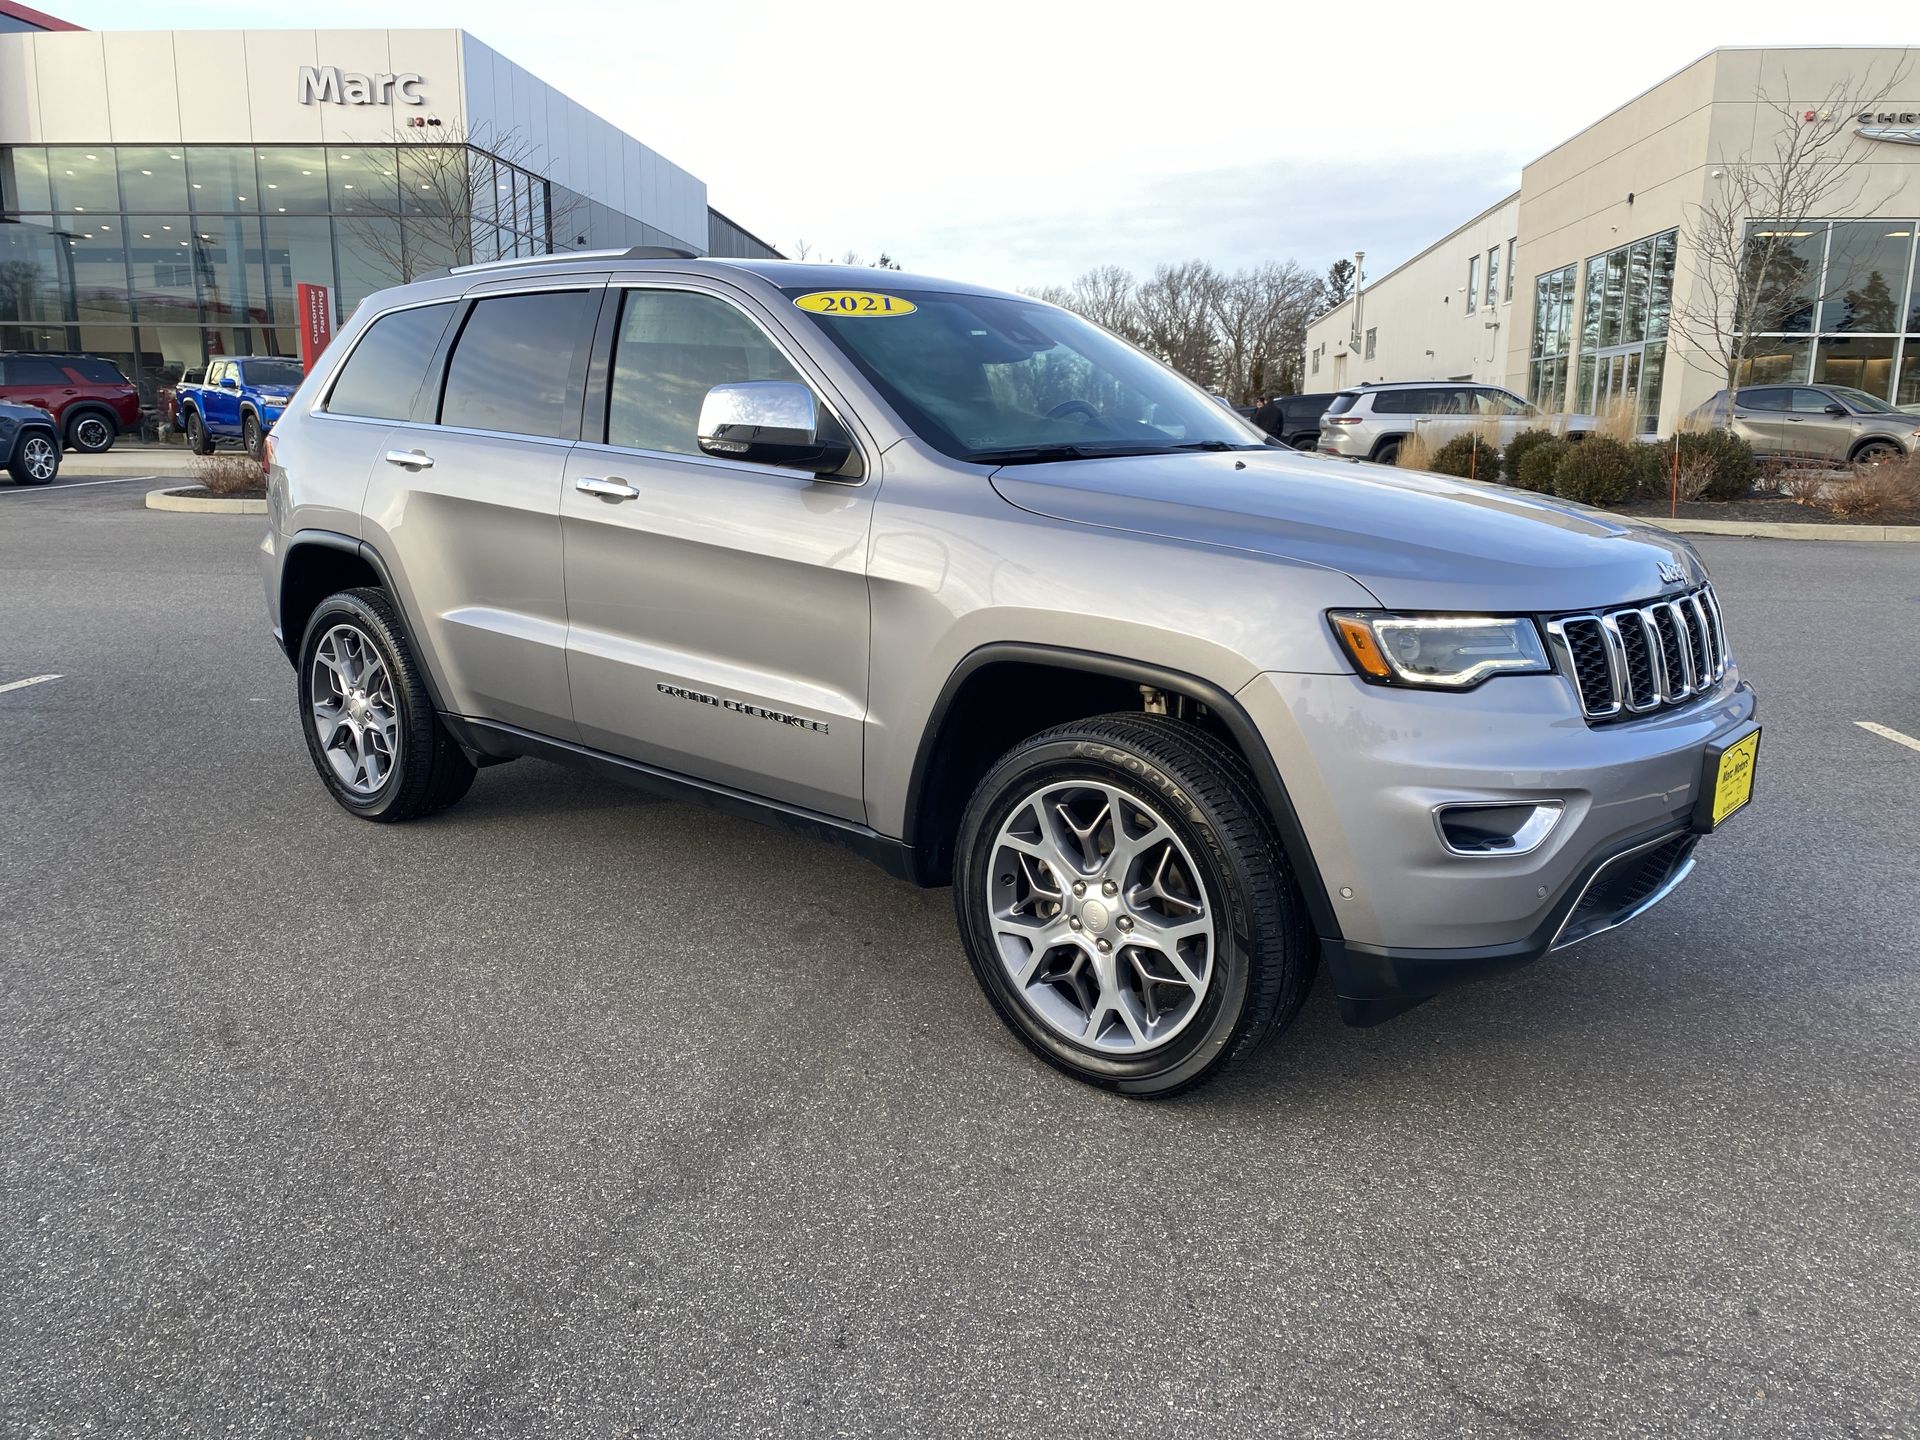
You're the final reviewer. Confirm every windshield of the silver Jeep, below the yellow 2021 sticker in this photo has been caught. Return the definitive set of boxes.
[785,288,1265,465]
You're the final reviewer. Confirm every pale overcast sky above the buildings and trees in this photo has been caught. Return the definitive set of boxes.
[56,0,1889,288]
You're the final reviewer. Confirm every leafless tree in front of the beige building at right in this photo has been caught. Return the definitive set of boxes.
[1668,65,1907,403]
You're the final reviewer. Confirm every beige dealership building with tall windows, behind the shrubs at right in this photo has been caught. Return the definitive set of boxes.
[1302,48,1920,434]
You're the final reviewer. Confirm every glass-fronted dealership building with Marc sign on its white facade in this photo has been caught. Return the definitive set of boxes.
[0,14,776,408]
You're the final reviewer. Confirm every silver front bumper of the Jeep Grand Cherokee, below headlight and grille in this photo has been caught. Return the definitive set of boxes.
[1238,670,1755,1025]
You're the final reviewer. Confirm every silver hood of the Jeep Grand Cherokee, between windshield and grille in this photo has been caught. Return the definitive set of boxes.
[993,449,1705,612]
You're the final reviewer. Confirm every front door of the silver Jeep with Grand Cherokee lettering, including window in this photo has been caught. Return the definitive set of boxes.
[561,286,877,820]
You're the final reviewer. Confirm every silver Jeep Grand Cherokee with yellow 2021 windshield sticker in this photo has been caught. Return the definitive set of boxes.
[261,252,1759,1094]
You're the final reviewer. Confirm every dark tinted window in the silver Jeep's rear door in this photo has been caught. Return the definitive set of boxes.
[440,290,599,440]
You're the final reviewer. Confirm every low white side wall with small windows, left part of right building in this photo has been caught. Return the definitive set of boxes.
[1300,196,1519,390]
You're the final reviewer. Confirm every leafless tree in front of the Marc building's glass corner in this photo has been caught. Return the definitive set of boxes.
[346,127,584,280]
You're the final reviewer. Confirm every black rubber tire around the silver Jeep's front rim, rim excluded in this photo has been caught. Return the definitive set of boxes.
[954,735,1252,1094]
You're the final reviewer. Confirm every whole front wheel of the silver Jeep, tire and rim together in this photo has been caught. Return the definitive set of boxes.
[954,714,1313,1096]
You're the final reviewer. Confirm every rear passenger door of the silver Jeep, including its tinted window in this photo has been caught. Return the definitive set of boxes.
[367,276,605,739]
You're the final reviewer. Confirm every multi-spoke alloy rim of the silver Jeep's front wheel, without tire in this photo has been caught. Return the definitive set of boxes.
[989,780,1215,1054]
